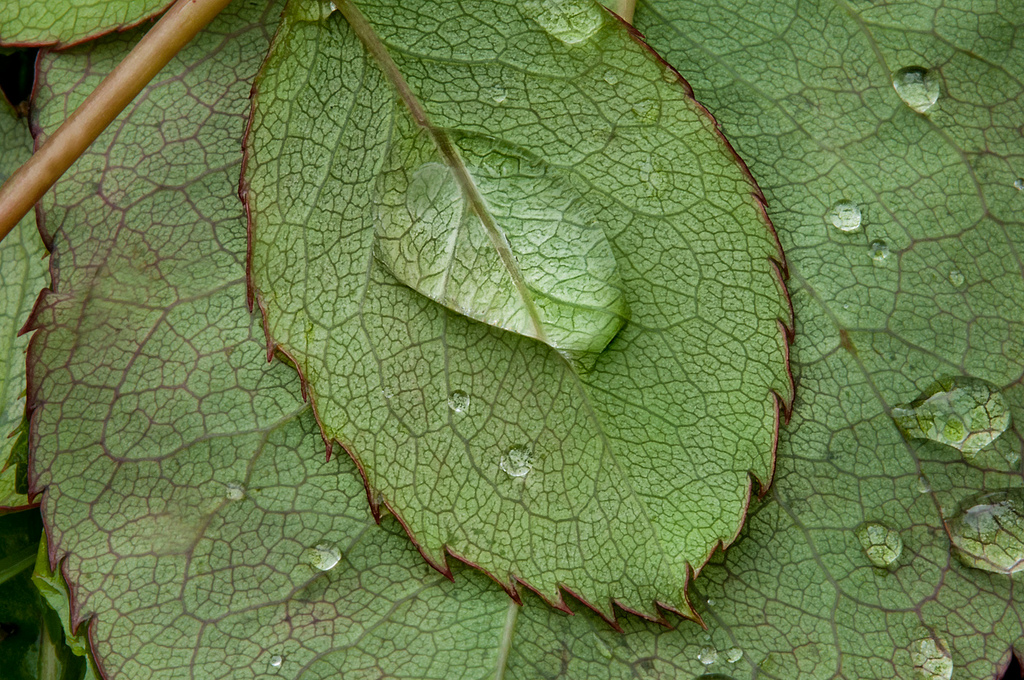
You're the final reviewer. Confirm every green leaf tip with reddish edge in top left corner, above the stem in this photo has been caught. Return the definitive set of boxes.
[0,0,173,47]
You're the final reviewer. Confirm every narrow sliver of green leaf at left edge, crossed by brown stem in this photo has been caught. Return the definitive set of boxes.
[0,97,46,509]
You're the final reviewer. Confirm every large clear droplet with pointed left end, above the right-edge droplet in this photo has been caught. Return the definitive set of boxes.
[892,377,1010,458]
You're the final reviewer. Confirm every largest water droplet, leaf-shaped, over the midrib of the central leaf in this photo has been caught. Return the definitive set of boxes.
[376,130,630,366]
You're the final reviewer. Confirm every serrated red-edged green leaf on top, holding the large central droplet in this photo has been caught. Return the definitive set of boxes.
[244,0,790,619]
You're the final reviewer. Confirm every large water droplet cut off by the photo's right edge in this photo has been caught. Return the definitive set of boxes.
[946,488,1024,573]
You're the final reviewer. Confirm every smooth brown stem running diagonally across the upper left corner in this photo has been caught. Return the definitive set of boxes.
[0,0,230,240]
